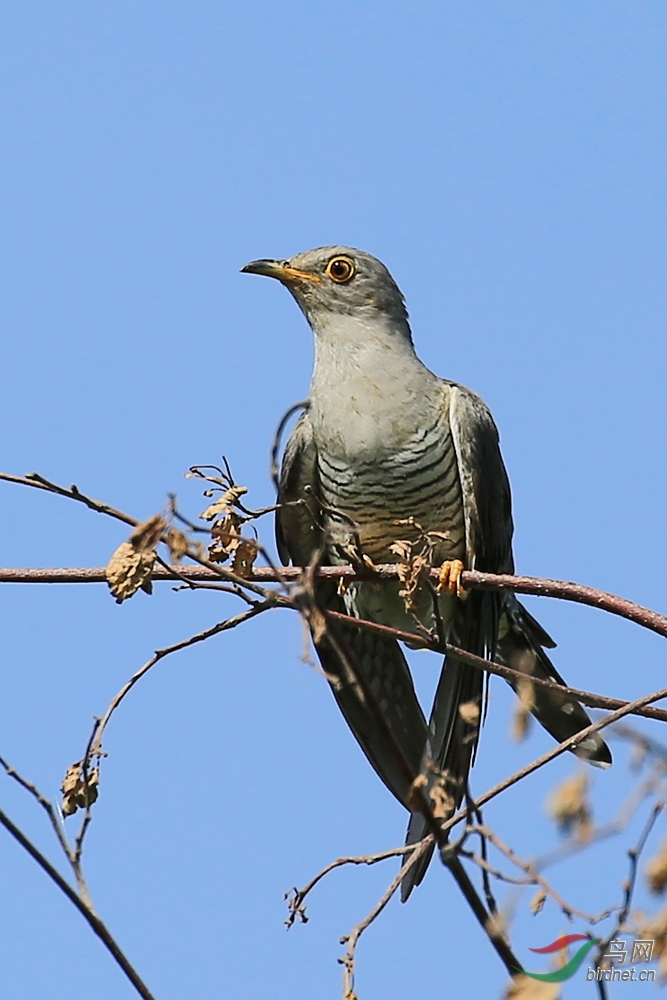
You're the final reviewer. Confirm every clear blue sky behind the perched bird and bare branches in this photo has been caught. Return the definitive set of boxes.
[0,0,667,1000]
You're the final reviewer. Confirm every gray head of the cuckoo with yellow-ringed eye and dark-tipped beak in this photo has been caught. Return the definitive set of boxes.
[241,246,410,337]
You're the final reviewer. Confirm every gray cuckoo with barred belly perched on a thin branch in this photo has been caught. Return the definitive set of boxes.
[243,246,611,898]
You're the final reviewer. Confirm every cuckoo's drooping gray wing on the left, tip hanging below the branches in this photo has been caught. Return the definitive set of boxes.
[276,411,426,807]
